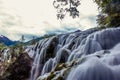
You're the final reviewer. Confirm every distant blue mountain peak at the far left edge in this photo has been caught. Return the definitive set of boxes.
[0,35,17,46]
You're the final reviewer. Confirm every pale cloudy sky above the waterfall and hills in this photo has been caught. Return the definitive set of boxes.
[0,0,98,40]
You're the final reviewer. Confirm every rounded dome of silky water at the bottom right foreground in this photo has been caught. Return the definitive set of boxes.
[67,57,120,80]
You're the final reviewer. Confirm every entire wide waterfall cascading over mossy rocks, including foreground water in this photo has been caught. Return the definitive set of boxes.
[26,28,120,80]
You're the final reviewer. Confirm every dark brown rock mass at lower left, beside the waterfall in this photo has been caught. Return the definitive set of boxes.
[1,53,32,80]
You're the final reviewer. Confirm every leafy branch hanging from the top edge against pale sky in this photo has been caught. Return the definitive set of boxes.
[53,0,80,19]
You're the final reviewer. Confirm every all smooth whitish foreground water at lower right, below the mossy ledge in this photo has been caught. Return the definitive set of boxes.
[67,44,120,80]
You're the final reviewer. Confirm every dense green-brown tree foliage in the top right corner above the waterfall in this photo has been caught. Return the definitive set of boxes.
[94,0,120,27]
